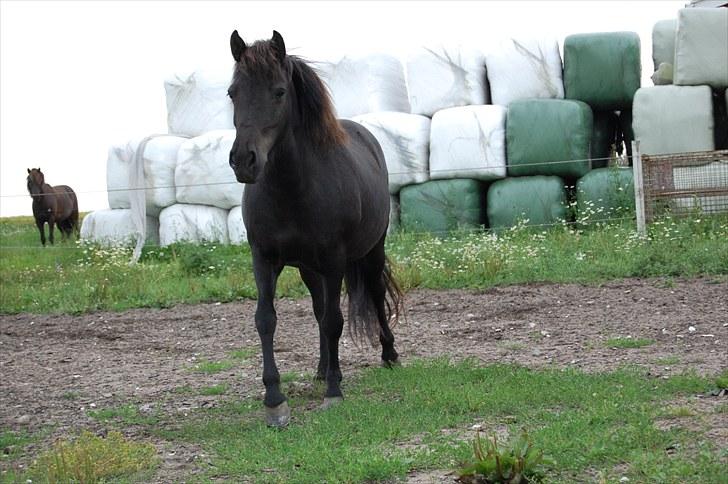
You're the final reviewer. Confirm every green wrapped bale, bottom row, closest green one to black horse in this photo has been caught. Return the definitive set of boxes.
[399,178,483,234]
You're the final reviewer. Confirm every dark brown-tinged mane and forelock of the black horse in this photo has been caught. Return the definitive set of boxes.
[235,41,347,147]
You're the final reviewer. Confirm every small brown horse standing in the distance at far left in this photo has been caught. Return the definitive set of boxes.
[28,168,78,245]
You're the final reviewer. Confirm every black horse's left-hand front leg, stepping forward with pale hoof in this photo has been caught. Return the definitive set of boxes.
[252,248,290,427]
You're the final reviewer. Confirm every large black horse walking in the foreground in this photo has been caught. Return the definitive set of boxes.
[228,30,402,426]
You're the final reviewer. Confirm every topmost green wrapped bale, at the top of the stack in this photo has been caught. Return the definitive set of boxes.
[564,32,642,110]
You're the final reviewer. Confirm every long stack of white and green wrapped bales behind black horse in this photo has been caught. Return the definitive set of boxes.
[82,9,728,245]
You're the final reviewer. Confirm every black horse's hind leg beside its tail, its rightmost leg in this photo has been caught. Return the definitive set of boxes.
[362,237,399,367]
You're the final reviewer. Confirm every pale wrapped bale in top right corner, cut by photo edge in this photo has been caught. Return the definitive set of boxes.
[674,8,728,88]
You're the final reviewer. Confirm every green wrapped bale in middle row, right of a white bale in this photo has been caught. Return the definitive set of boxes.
[506,99,594,178]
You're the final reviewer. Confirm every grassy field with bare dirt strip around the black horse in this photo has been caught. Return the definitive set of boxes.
[0,218,728,483]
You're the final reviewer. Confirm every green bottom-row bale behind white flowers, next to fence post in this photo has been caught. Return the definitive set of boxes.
[576,167,634,223]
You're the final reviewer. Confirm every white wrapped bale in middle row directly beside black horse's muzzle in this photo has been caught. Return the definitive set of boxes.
[174,129,243,210]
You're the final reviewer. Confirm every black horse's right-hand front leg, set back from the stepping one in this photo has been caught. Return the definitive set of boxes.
[321,272,344,407]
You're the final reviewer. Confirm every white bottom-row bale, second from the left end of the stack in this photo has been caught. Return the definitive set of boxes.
[159,203,230,246]
